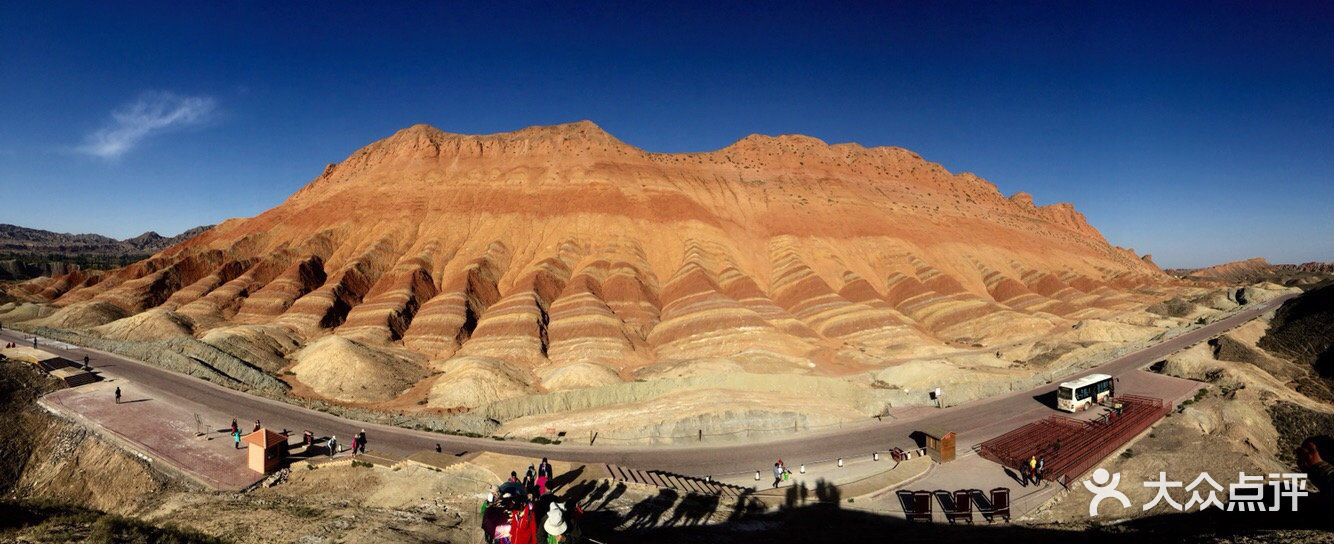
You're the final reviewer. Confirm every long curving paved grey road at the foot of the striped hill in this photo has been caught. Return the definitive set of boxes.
[0,295,1293,476]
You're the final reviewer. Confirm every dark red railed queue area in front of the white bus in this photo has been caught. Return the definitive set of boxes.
[980,395,1171,481]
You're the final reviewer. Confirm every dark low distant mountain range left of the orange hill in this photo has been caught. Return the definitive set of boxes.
[0,224,212,280]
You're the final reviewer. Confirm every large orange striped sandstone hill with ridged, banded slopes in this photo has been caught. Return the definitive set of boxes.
[7,121,1171,409]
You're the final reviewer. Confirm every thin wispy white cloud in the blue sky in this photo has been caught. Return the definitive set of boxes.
[79,92,217,159]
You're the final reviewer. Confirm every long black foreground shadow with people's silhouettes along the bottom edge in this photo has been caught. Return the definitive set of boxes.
[536,464,1334,544]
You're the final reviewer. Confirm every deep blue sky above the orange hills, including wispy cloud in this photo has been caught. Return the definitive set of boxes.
[0,1,1334,267]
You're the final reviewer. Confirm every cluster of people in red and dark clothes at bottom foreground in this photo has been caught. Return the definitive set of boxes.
[482,457,583,544]
